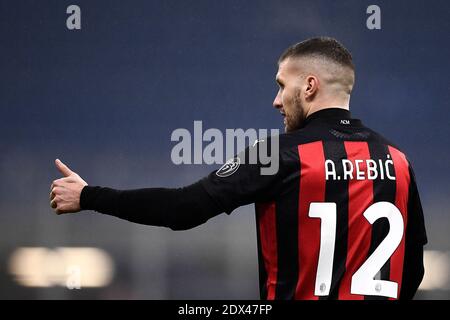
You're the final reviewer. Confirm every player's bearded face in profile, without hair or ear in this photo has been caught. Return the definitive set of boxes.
[273,58,306,132]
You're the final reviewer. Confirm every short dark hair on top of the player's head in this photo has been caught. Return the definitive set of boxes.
[278,37,355,71]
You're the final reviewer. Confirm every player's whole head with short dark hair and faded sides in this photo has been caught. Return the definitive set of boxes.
[274,38,355,132]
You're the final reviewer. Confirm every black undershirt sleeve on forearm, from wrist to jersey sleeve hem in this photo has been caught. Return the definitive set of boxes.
[80,182,223,230]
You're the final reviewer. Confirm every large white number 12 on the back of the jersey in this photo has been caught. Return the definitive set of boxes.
[308,201,404,298]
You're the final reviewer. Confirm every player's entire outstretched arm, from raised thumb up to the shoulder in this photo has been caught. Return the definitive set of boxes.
[50,138,282,230]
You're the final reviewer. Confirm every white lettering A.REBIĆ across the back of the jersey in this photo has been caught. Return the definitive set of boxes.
[325,155,395,180]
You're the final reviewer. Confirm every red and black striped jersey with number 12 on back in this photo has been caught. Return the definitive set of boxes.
[202,109,427,299]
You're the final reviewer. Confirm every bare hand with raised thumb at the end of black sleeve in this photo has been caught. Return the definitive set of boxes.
[50,159,88,214]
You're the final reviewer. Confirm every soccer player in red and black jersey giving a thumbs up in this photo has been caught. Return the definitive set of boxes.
[50,37,427,300]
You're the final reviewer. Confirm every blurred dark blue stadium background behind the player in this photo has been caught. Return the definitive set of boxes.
[0,0,450,299]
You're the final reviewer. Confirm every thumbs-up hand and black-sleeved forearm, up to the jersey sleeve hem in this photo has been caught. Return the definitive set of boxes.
[50,159,223,230]
